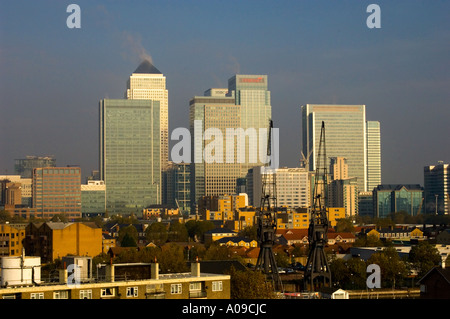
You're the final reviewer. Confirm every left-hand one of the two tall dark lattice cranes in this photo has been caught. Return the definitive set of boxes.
[255,120,283,292]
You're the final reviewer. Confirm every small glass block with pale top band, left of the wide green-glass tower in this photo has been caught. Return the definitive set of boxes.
[81,180,106,217]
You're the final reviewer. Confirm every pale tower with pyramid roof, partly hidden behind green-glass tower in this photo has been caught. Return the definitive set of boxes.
[125,60,169,170]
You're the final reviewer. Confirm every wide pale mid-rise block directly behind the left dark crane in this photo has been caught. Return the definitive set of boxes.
[247,166,309,208]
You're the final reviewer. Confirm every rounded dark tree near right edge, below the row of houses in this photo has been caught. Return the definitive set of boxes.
[408,241,441,277]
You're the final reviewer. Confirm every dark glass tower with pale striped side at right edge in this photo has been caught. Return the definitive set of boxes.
[424,162,450,214]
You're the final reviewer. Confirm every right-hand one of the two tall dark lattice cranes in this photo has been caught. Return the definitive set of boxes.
[304,122,331,291]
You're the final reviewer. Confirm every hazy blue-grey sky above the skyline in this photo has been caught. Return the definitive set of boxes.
[0,0,450,185]
